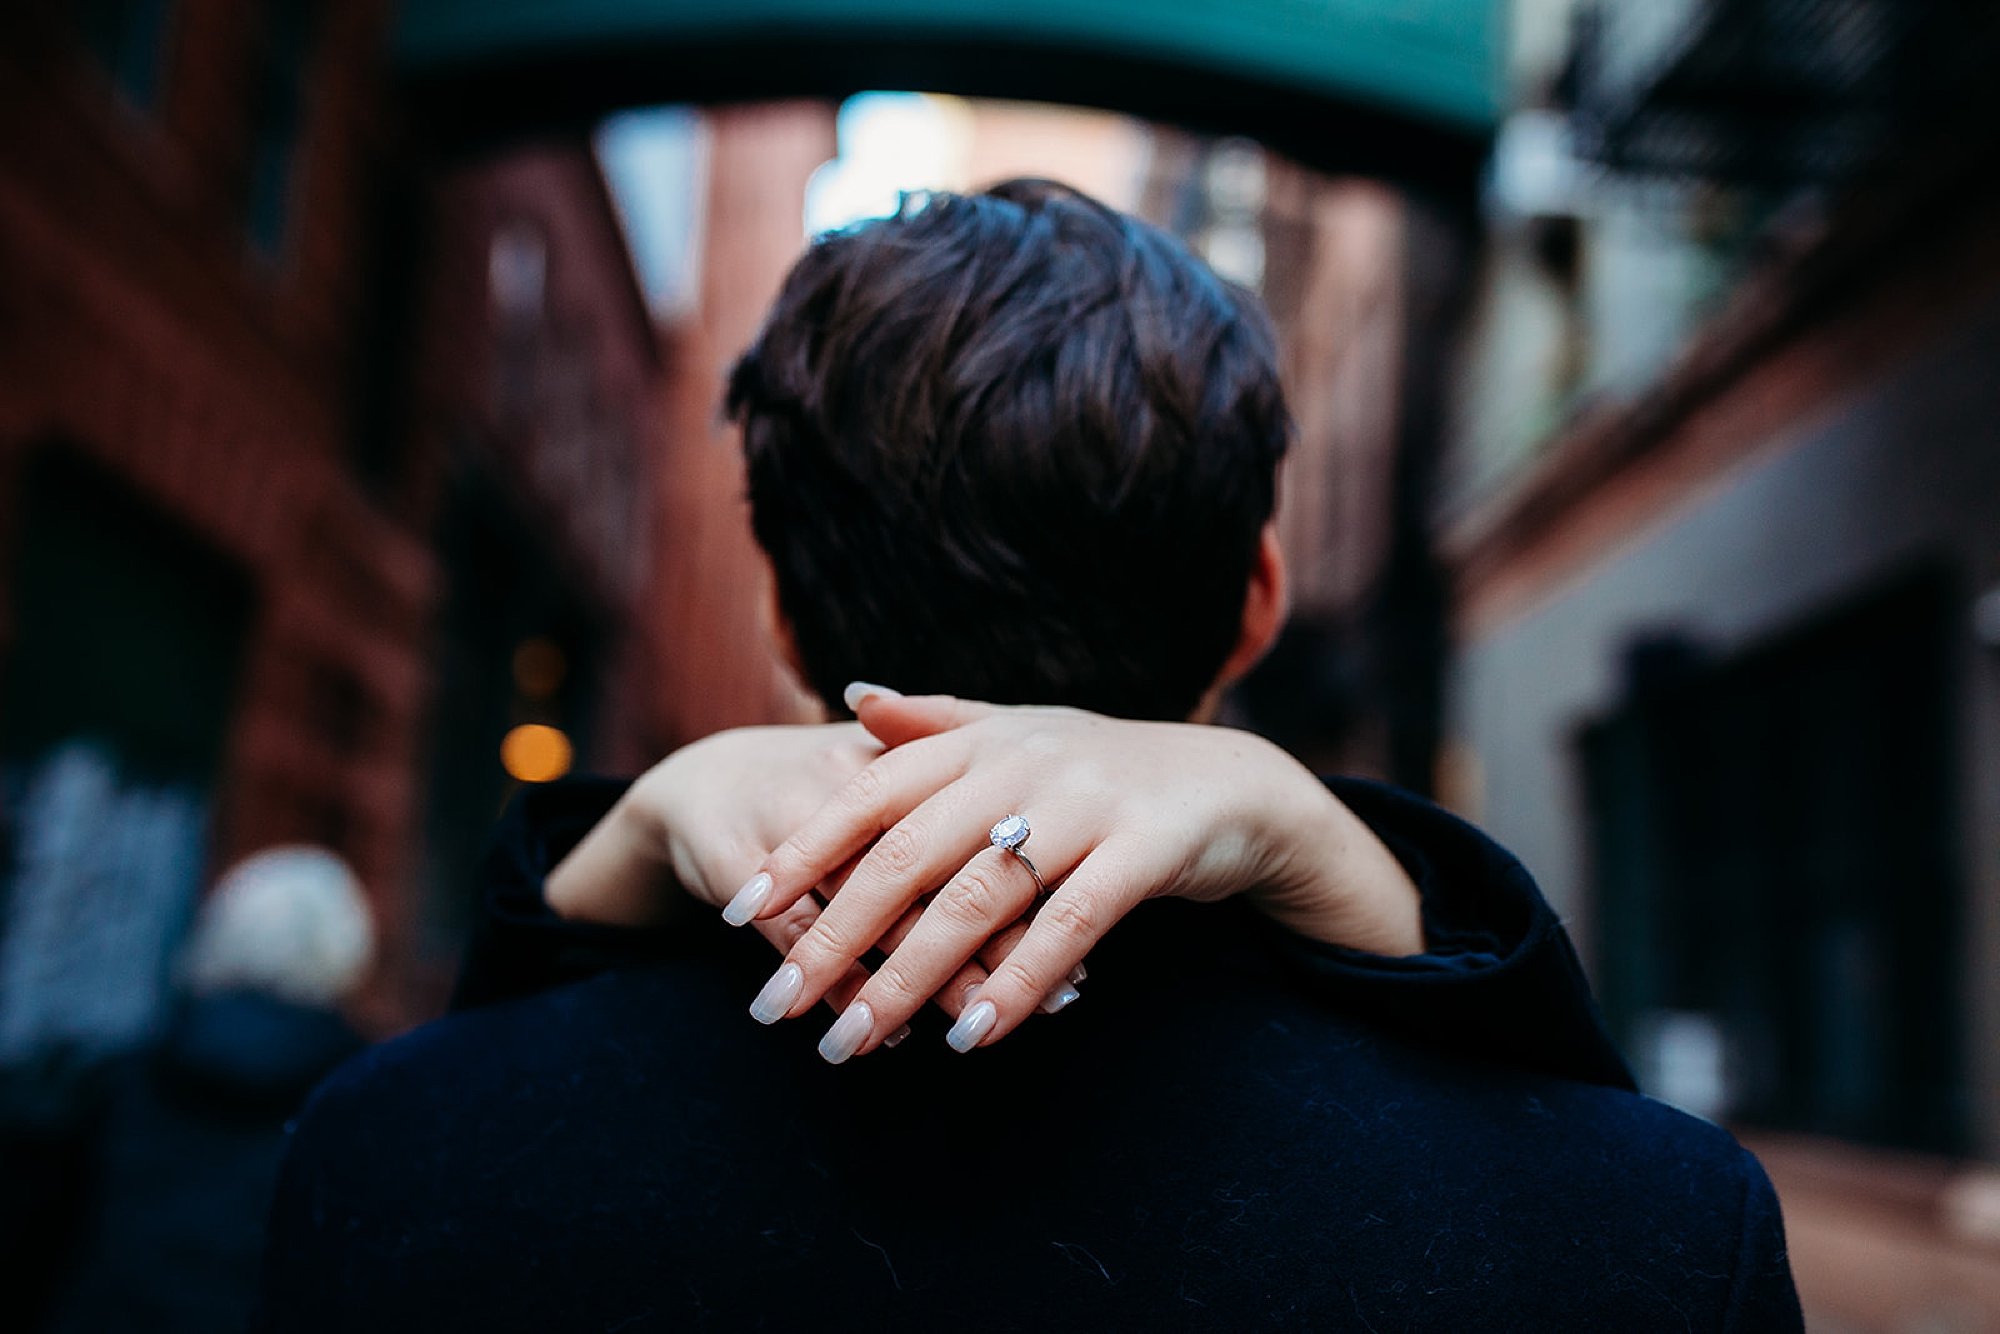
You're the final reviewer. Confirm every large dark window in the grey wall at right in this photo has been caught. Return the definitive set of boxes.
[1582,574,1966,1152]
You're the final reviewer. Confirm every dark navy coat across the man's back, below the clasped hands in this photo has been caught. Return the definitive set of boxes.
[258,788,1800,1332]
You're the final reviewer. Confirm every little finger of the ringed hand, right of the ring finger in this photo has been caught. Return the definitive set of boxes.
[940,842,1148,1052]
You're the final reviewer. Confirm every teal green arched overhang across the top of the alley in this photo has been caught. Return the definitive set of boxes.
[396,0,1504,136]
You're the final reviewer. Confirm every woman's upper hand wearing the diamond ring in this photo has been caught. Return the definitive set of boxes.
[726,690,1422,1062]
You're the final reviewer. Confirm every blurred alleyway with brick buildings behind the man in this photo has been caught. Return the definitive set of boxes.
[0,0,2000,1332]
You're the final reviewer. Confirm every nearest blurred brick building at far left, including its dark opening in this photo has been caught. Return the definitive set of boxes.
[0,2,422,1056]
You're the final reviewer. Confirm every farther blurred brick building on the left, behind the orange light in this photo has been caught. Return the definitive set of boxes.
[398,136,666,968]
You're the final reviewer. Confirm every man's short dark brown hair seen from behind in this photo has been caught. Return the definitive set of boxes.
[726,180,1290,718]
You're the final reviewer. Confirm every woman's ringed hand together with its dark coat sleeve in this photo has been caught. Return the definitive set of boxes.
[740,694,1630,1084]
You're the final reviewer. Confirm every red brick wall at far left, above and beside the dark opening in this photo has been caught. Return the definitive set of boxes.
[0,0,432,1032]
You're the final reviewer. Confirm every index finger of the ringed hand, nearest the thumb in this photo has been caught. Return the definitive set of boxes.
[722,738,966,928]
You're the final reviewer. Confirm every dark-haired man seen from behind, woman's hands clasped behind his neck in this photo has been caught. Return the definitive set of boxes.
[264,182,1800,1330]
